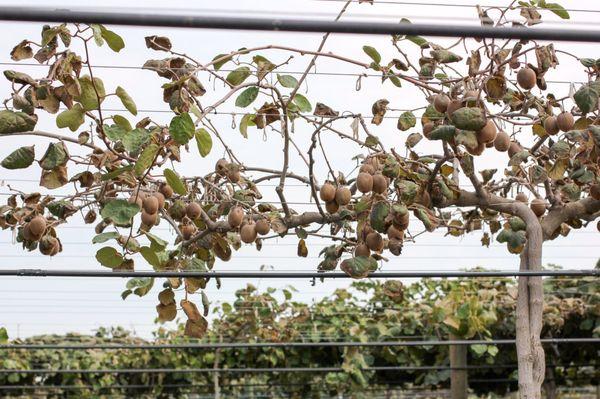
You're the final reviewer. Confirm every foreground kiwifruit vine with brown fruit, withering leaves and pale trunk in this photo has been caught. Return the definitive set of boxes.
[0,1,600,399]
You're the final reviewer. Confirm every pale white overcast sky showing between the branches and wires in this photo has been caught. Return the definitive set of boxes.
[0,0,600,337]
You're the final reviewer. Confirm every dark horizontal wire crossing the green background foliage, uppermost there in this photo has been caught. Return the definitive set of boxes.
[0,338,600,350]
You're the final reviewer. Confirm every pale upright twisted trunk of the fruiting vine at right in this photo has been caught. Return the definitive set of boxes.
[516,219,546,399]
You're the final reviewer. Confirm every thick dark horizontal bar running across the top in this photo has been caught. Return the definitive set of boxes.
[0,7,600,42]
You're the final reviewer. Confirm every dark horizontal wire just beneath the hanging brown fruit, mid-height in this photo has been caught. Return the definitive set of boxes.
[0,269,600,279]
